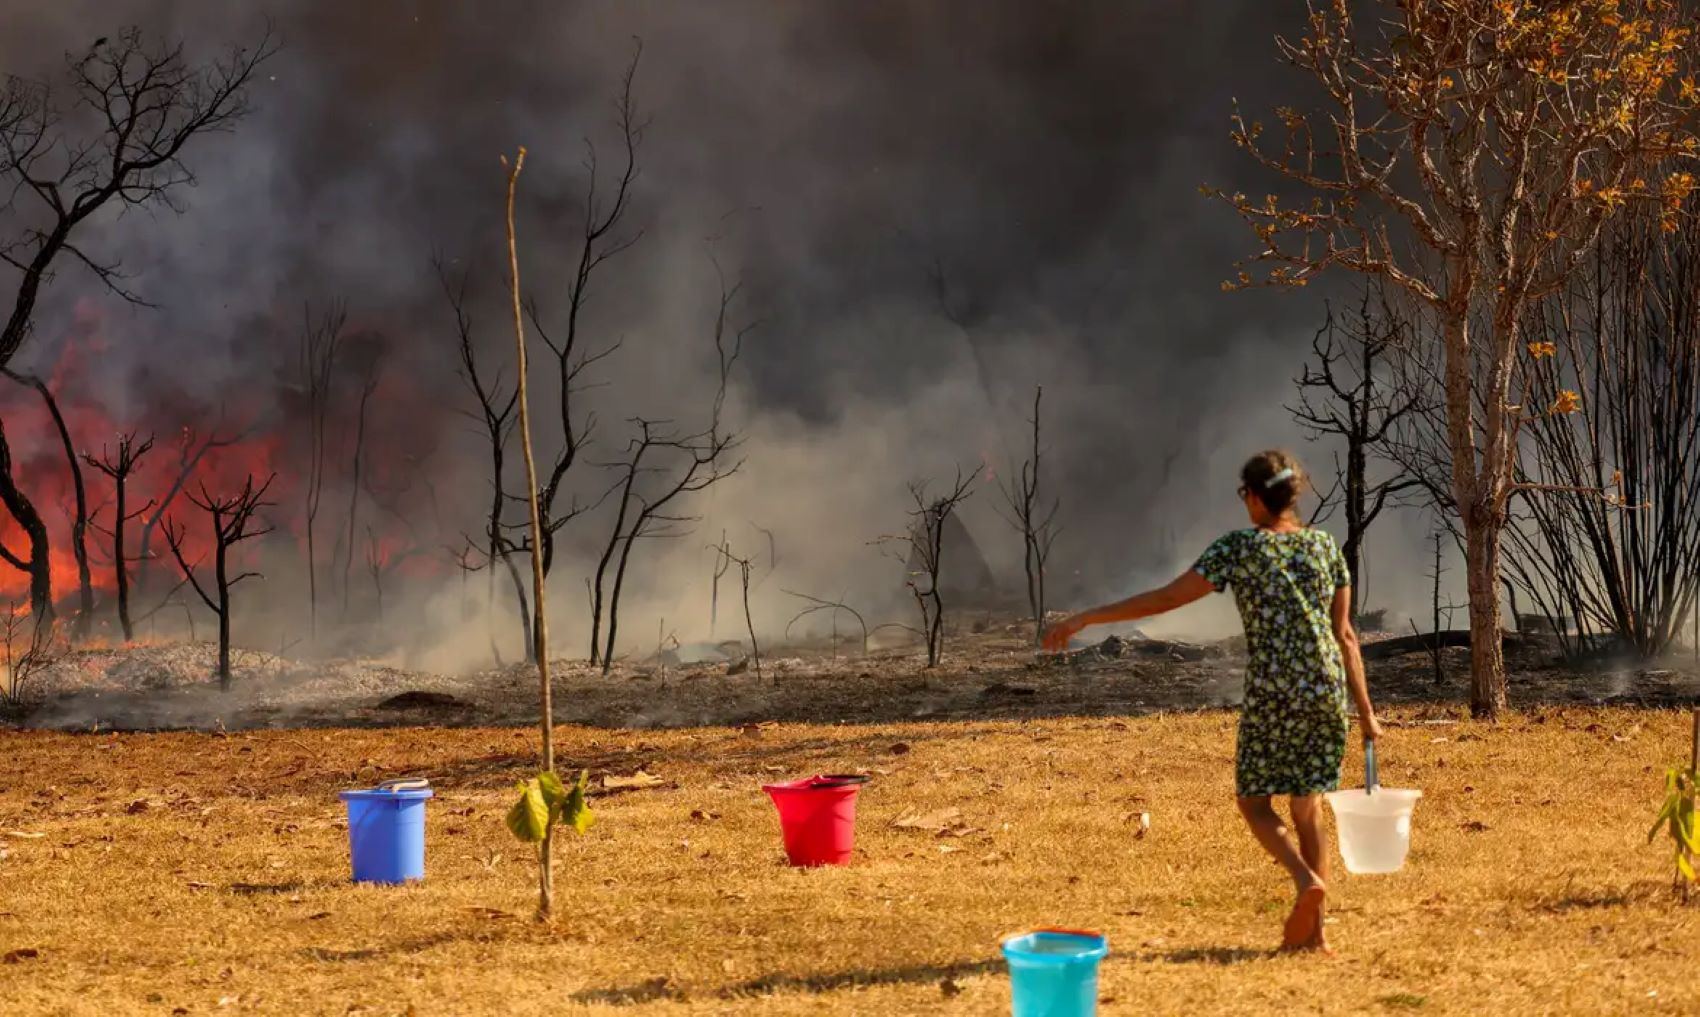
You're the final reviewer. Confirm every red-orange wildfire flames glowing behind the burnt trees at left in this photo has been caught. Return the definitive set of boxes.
[0,308,454,629]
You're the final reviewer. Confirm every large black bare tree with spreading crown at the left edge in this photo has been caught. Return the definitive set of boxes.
[0,29,275,621]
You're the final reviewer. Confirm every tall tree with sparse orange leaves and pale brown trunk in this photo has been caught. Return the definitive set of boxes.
[1205,0,1700,716]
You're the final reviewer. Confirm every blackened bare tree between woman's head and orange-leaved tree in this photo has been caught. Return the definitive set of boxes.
[1287,287,1423,617]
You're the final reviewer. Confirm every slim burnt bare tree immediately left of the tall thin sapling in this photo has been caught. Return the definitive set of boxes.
[435,260,536,665]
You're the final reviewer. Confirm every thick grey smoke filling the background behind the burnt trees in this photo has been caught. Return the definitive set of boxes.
[0,2,1448,680]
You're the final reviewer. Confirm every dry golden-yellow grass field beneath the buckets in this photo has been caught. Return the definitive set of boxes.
[0,707,1700,1017]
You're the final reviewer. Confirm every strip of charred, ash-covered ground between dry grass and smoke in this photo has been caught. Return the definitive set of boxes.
[5,624,1700,731]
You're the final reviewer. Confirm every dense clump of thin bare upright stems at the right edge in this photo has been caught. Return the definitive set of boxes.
[1505,211,1700,658]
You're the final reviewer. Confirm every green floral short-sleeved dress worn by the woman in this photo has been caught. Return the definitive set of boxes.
[1193,529,1352,796]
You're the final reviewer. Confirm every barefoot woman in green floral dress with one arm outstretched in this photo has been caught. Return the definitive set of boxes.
[1046,451,1380,952]
